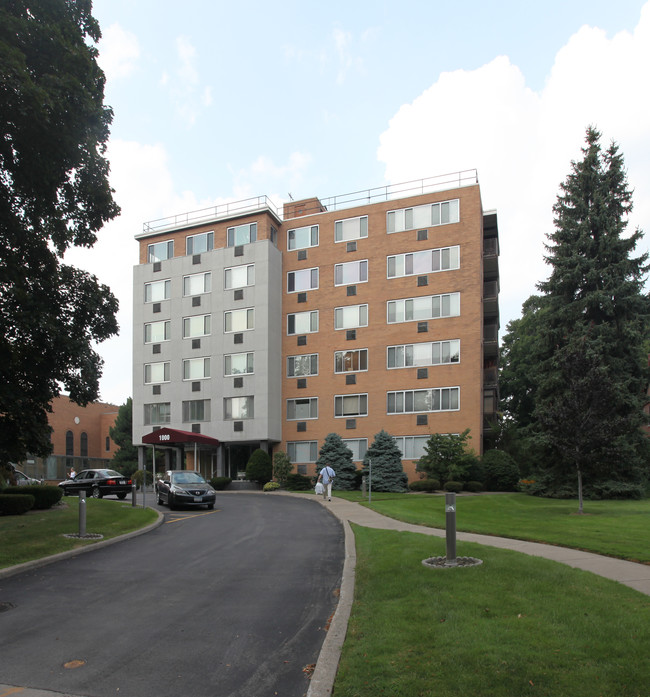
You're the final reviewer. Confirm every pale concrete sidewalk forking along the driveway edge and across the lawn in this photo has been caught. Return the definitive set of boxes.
[302,494,650,697]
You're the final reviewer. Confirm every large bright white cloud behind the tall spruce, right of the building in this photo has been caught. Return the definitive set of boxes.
[378,3,650,330]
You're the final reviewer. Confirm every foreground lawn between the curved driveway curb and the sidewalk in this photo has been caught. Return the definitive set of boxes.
[333,526,650,697]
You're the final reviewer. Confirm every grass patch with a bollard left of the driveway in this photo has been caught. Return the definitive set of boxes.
[0,496,157,568]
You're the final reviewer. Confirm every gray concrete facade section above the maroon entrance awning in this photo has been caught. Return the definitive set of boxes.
[133,213,282,475]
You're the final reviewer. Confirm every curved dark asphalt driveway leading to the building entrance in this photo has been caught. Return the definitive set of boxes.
[0,494,344,697]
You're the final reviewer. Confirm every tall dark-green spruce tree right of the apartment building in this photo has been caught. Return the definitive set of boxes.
[534,128,650,510]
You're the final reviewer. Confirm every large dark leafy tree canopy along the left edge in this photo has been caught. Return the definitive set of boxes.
[0,0,119,462]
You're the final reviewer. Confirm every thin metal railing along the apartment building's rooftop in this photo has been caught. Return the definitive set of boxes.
[142,169,478,235]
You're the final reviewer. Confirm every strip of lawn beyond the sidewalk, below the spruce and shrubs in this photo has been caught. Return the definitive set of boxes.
[336,491,650,564]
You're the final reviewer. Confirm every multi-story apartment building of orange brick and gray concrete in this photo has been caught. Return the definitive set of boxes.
[133,171,499,479]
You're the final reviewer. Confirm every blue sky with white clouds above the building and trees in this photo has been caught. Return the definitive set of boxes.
[66,0,650,405]
